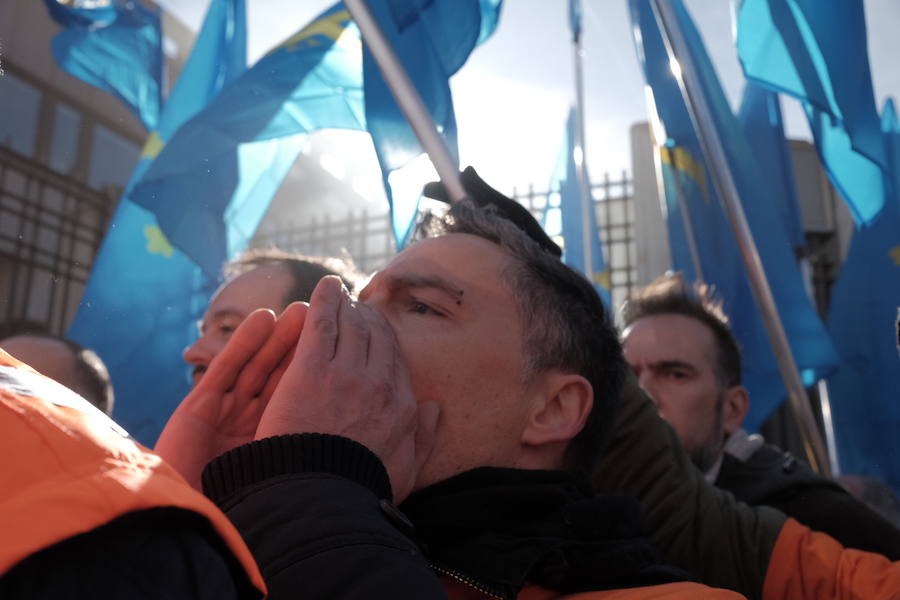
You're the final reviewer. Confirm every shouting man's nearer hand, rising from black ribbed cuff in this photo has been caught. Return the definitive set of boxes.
[256,277,439,504]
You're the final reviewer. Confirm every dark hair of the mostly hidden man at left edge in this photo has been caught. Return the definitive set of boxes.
[0,320,115,415]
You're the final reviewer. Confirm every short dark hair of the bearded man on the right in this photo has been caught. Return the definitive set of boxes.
[622,273,741,388]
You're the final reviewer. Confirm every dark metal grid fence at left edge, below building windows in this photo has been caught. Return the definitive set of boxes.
[0,147,115,333]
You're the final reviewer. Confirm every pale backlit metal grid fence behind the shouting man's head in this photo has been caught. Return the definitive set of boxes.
[251,173,637,306]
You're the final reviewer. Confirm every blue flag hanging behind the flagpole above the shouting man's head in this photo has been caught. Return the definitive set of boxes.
[363,0,503,247]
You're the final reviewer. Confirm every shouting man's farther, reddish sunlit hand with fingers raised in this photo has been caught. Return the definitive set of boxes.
[155,302,308,489]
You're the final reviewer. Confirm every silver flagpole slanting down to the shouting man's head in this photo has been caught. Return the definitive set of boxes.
[344,0,467,202]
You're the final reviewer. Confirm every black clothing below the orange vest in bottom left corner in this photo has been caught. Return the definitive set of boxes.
[0,508,260,600]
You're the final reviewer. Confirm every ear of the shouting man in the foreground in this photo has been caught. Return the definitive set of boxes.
[522,371,594,446]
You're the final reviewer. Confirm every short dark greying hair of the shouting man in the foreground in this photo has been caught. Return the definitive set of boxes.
[418,202,627,474]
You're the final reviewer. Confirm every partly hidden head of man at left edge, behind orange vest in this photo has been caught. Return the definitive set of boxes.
[0,321,115,415]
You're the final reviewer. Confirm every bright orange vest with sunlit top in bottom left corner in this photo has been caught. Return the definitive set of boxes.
[0,349,265,596]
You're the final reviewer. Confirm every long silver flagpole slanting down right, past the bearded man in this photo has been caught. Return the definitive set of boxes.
[651,0,831,477]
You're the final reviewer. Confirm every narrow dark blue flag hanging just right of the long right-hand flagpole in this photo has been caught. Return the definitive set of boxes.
[738,81,806,249]
